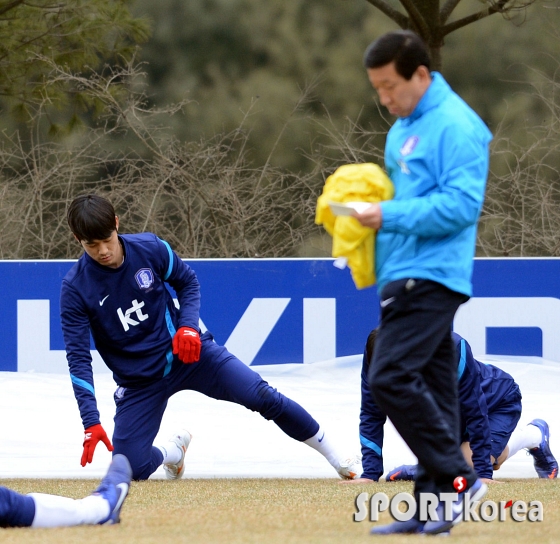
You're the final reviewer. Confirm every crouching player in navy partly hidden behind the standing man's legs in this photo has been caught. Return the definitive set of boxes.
[353,329,558,483]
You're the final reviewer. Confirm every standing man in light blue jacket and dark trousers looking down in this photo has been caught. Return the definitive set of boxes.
[353,31,492,534]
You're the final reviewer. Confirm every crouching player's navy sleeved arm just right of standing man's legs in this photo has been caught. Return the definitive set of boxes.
[457,339,493,479]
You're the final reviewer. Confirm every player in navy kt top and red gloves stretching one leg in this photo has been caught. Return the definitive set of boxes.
[60,195,361,480]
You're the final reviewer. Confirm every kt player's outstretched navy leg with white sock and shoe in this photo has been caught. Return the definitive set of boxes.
[179,334,361,478]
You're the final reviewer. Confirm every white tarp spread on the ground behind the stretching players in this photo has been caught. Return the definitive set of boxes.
[0,356,560,478]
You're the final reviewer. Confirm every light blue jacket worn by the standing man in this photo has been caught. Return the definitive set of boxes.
[375,72,492,296]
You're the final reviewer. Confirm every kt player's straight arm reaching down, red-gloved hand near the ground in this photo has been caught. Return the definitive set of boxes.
[60,281,113,466]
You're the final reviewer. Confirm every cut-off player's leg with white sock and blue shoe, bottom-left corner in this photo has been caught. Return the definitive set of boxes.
[0,455,132,529]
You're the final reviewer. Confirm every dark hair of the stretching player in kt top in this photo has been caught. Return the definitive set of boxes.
[66,195,117,242]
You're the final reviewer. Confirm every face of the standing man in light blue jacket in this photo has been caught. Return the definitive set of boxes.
[367,62,431,117]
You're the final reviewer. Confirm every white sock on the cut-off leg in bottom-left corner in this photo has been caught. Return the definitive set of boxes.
[29,493,109,528]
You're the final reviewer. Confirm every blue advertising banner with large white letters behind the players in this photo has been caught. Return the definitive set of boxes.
[0,259,560,372]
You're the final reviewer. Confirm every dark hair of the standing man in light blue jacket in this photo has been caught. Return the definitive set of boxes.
[364,30,430,80]
